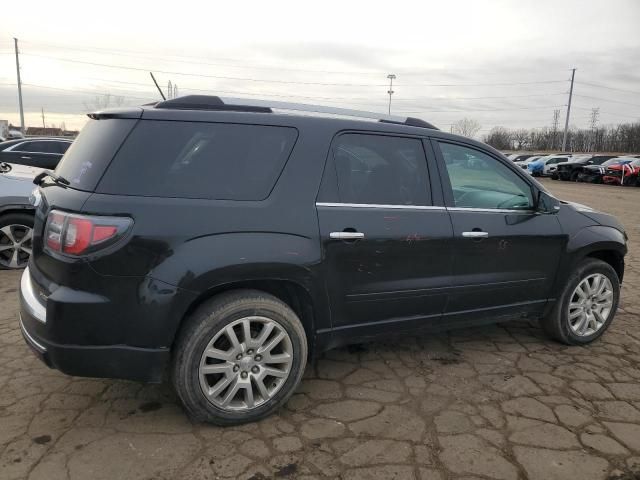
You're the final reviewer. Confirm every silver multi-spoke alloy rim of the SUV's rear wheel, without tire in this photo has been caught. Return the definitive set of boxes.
[198,316,293,411]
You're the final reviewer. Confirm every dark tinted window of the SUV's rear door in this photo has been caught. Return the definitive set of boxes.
[333,134,431,205]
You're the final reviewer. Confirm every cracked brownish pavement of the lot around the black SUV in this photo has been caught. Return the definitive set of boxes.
[0,180,640,480]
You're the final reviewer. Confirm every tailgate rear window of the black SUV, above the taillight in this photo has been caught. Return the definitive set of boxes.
[56,118,137,191]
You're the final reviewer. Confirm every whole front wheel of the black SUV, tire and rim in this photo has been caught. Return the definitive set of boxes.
[541,258,620,345]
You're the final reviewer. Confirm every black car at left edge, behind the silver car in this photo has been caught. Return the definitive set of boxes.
[0,137,72,170]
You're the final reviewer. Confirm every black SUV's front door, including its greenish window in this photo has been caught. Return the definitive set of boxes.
[434,141,566,321]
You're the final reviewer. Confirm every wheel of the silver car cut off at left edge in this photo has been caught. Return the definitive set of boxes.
[0,213,33,270]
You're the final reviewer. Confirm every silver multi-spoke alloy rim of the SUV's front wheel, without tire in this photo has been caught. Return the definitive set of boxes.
[568,273,613,337]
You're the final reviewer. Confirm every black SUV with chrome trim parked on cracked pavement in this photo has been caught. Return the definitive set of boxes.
[20,97,627,424]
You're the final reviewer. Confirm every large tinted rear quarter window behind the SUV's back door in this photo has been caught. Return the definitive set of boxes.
[98,120,297,200]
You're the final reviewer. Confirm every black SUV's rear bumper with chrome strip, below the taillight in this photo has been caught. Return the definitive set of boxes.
[20,268,170,383]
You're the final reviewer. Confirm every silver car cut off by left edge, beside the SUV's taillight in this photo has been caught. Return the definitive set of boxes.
[0,163,42,270]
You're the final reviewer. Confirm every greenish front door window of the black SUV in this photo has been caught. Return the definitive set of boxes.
[439,143,533,209]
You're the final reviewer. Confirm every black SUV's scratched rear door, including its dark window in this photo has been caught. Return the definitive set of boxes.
[316,132,452,339]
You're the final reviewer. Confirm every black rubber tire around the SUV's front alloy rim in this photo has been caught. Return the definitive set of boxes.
[541,258,620,345]
